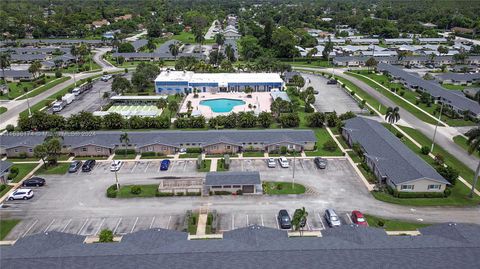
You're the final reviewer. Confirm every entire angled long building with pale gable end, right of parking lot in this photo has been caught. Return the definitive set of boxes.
[342,117,450,192]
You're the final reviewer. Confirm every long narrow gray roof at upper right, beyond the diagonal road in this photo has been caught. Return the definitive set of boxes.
[377,63,480,115]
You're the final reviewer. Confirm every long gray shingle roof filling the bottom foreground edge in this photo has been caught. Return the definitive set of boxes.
[0,224,480,269]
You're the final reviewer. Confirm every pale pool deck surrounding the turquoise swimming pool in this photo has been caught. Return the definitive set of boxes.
[180,92,272,118]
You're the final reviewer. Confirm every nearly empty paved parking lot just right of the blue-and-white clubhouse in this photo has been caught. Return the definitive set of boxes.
[302,71,362,114]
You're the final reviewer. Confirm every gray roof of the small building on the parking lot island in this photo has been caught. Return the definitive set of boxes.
[205,171,262,186]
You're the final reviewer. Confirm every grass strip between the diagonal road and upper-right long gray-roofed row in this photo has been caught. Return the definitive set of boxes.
[345,72,437,124]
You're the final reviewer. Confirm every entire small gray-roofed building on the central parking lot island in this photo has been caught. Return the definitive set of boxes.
[204,171,262,194]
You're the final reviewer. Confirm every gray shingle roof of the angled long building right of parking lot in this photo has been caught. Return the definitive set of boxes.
[344,117,449,185]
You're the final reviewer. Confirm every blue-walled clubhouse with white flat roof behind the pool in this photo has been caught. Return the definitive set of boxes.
[155,71,285,94]
